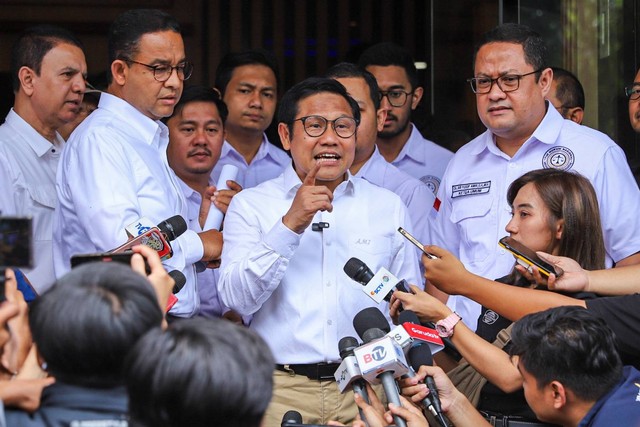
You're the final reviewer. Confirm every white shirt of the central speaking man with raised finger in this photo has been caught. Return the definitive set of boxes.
[218,166,422,364]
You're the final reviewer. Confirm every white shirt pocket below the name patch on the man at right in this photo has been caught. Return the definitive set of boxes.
[444,196,498,267]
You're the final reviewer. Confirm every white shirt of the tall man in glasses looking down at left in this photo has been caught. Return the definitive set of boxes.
[54,93,204,317]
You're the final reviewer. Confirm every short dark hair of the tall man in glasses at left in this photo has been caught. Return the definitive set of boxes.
[108,9,181,81]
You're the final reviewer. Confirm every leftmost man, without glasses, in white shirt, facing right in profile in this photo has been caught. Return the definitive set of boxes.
[0,26,87,292]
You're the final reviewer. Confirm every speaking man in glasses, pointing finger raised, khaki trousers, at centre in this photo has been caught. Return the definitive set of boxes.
[218,78,421,427]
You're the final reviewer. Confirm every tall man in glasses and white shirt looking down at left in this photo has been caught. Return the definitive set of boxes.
[54,9,222,317]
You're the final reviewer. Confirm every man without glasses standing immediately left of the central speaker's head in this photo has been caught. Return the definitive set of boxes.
[212,50,291,188]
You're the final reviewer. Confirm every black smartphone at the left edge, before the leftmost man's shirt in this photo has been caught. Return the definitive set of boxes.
[0,217,33,268]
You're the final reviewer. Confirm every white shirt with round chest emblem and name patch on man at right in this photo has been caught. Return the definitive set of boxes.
[433,104,640,329]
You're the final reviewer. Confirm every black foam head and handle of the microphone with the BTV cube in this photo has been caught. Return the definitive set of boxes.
[353,307,407,427]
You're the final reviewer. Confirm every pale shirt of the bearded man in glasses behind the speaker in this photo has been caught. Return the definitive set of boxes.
[391,123,453,194]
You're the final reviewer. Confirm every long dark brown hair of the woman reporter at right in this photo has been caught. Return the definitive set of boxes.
[507,169,605,270]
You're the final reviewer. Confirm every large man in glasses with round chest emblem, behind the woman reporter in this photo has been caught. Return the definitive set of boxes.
[433,24,640,340]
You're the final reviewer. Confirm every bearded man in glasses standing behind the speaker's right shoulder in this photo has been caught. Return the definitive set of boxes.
[358,42,453,194]
